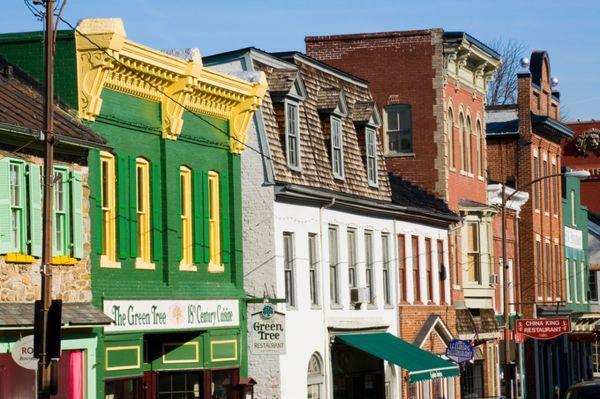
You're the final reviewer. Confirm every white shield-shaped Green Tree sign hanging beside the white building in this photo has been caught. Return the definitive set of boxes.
[250,303,285,355]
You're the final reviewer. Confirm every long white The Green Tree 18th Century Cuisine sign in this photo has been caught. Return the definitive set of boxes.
[104,299,240,332]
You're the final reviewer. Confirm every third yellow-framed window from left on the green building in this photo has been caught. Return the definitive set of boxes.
[179,166,194,270]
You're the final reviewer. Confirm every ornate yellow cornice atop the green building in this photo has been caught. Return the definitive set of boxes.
[75,18,267,154]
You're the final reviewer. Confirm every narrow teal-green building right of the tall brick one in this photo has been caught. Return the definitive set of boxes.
[556,168,598,390]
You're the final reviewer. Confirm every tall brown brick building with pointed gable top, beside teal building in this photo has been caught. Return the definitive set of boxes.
[487,51,572,398]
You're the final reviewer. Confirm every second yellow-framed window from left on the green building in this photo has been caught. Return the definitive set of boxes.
[135,158,151,264]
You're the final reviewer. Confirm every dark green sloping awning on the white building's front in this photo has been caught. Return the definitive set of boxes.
[336,333,460,382]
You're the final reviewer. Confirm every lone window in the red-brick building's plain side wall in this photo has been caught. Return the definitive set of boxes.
[385,104,413,155]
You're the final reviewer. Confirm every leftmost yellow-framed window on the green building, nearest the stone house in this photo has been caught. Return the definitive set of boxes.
[100,152,117,266]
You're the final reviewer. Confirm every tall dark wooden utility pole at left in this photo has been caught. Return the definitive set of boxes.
[37,0,55,399]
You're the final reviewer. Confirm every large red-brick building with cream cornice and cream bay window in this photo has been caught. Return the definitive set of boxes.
[305,29,500,396]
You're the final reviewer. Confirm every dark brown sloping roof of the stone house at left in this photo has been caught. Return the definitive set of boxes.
[0,57,106,144]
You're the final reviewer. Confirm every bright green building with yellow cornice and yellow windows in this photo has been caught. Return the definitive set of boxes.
[0,19,265,399]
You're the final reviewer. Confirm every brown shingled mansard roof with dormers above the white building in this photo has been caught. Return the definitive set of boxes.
[254,55,391,201]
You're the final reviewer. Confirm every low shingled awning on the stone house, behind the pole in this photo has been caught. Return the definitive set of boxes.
[0,302,113,330]
